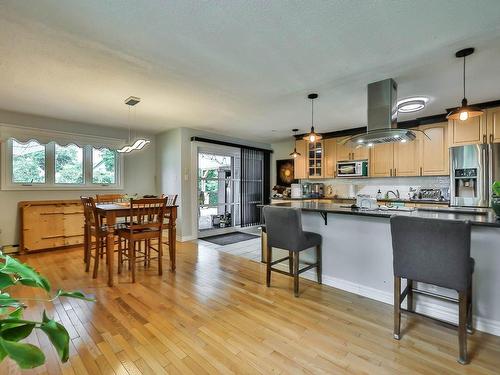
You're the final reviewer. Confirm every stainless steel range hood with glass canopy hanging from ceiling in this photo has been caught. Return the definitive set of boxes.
[343,78,416,147]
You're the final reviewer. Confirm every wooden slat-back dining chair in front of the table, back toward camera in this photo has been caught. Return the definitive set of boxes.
[117,198,167,283]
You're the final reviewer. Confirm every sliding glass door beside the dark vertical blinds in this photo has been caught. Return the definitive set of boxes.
[197,148,241,237]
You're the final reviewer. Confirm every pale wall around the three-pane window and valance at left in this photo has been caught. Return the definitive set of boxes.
[0,110,157,245]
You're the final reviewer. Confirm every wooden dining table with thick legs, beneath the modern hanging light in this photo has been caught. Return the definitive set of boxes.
[96,202,178,286]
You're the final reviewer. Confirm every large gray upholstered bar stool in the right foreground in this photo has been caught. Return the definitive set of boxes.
[391,216,474,364]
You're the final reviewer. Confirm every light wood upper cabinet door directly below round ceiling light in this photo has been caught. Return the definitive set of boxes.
[393,132,422,176]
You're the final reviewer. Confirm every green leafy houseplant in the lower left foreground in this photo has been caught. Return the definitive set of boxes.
[0,252,94,369]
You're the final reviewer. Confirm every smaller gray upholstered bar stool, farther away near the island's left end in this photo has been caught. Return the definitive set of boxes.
[264,206,322,297]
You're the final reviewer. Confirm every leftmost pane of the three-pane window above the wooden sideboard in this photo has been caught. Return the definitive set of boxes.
[12,139,45,184]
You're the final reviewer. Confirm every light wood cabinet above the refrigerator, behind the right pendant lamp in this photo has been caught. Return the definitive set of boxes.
[448,115,487,146]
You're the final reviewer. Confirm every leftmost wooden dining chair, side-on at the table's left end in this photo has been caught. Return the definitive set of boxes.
[80,197,107,279]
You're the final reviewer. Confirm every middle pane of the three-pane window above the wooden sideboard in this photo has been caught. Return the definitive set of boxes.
[54,143,83,184]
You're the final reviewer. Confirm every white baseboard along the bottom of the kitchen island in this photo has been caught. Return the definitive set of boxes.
[275,264,500,336]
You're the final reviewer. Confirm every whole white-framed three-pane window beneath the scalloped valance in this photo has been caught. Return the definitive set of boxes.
[1,137,123,190]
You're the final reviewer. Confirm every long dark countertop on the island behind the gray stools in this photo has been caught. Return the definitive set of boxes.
[272,201,500,228]
